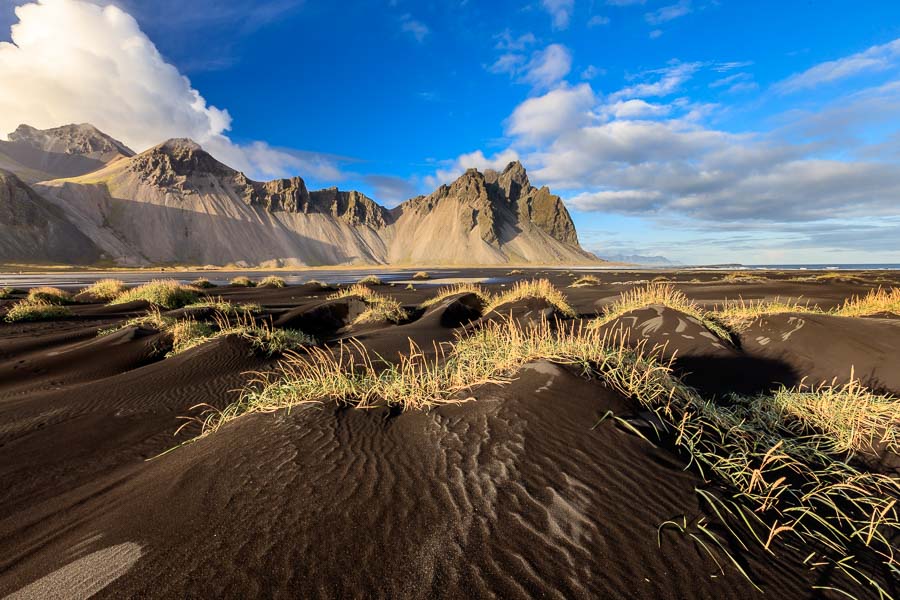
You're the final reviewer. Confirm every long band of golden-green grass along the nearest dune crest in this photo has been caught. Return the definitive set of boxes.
[203,319,900,597]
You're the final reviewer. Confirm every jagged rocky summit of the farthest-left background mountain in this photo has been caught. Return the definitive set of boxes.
[8,123,134,161]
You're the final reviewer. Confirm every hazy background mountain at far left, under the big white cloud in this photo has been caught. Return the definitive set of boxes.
[0,123,134,183]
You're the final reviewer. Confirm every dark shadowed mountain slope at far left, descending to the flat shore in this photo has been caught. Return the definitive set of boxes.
[0,170,103,264]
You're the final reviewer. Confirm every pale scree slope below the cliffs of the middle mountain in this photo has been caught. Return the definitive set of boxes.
[34,182,372,266]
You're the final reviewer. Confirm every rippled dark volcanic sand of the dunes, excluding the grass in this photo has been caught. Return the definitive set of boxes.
[0,270,900,598]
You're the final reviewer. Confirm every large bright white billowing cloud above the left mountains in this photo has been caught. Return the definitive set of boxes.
[0,0,337,180]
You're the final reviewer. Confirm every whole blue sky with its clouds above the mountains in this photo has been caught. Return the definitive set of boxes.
[0,0,900,263]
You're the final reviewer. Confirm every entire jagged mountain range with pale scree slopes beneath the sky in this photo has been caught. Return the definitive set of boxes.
[0,124,598,267]
